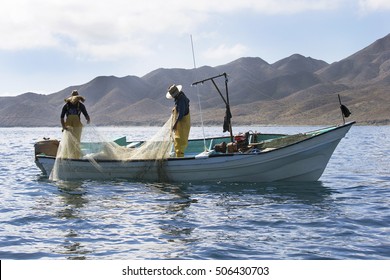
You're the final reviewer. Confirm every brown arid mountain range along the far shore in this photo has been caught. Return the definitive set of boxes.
[0,34,390,127]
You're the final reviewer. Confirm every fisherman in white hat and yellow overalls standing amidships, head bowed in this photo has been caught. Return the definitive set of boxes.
[166,84,191,157]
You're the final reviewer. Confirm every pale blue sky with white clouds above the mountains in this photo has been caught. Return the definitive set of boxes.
[0,0,390,96]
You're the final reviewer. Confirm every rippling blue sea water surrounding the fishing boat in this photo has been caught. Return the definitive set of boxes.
[0,126,390,260]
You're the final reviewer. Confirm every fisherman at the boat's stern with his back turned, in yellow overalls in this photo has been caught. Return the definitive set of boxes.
[61,90,91,158]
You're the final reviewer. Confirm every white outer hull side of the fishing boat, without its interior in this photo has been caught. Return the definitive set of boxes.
[36,123,353,182]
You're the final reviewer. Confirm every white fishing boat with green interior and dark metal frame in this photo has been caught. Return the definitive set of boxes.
[35,73,355,182]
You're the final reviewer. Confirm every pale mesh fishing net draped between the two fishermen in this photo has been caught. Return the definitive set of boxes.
[49,117,173,181]
